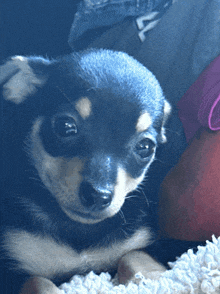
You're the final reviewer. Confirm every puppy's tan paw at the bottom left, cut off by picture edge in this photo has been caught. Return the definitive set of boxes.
[20,277,63,294]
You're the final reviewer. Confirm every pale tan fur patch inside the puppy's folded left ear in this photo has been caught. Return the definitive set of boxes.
[3,56,46,104]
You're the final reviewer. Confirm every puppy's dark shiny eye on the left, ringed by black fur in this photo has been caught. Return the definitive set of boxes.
[53,116,77,137]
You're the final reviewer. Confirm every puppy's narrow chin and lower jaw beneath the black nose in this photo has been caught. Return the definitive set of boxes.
[62,207,120,225]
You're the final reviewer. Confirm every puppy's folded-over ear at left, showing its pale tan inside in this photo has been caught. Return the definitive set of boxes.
[0,56,50,104]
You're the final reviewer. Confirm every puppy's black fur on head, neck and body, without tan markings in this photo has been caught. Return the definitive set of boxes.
[0,50,169,293]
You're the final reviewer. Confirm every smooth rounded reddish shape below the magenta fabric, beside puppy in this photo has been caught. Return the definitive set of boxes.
[159,129,220,241]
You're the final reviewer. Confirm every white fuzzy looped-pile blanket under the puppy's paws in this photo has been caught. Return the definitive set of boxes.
[60,236,220,294]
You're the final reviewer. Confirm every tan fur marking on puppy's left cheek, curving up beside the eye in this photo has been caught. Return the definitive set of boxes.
[30,118,84,210]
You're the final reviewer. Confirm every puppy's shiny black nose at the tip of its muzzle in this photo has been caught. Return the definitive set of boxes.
[79,182,112,211]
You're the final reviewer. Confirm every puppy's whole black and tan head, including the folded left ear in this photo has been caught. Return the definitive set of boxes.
[2,50,170,224]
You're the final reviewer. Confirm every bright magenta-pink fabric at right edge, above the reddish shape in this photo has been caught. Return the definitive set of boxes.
[177,55,220,141]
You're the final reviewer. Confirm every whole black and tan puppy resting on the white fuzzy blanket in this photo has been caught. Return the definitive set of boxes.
[0,50,170,294]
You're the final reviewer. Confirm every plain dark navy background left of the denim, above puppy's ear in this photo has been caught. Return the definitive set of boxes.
[0,0,80,61]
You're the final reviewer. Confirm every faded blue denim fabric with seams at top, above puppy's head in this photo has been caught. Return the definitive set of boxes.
[69,0,170,43]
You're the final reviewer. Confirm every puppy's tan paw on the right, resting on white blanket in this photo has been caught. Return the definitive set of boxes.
[118,251,166,284]
